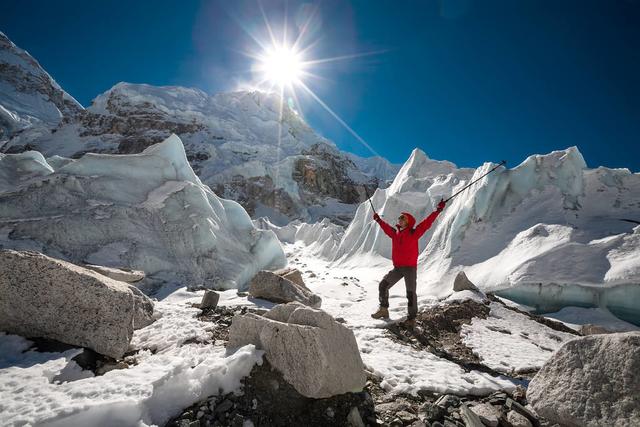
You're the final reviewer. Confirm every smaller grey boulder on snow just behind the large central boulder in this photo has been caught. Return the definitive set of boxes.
[249,270,322,308]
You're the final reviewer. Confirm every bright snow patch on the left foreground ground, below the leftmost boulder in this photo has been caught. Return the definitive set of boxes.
[0,289,263,426]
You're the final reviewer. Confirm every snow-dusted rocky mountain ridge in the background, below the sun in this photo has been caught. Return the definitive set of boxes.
[0,33,399,225]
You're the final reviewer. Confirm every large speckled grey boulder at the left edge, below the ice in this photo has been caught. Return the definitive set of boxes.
[0,250,153,359]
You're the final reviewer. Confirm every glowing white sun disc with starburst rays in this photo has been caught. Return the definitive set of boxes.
[258,46,304,87]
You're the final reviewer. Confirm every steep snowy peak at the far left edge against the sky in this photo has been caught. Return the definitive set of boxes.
[0,32,83,141]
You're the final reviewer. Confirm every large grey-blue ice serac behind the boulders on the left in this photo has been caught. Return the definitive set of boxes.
[0,135,286,288]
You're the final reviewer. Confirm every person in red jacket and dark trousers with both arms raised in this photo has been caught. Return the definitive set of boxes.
[371,200,446,326]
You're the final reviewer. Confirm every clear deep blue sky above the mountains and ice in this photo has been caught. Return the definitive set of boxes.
[0,0,640,172]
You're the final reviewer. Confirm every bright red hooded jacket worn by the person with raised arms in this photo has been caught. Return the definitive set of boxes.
[376,210,440,267]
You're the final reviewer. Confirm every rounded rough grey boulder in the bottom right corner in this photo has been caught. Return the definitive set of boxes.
[527,332,640,426]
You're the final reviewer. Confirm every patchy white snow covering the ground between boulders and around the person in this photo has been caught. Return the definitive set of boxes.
[0,243,636,426]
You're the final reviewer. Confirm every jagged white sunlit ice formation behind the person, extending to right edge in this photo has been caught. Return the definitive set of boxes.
[335,147,640,324]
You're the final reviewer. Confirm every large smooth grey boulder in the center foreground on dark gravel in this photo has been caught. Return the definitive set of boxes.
[227,303,366,398]
